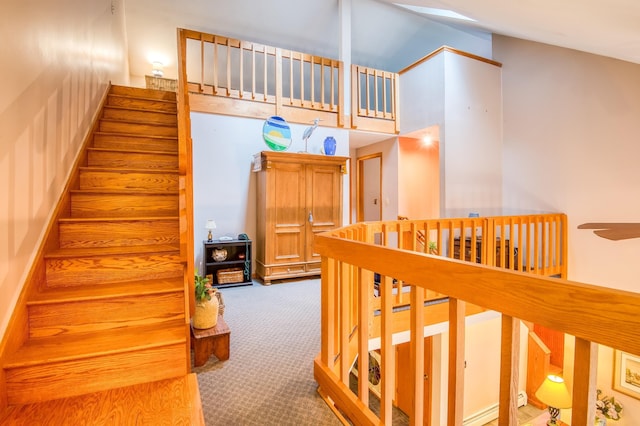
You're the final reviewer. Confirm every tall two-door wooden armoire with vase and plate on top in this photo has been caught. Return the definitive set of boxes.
[253,151,348,284]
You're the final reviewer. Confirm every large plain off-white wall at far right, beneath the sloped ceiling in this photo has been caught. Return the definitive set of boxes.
[494,37,640,426]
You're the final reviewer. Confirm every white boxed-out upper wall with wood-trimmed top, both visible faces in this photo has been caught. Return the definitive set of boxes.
[400,51,502,217]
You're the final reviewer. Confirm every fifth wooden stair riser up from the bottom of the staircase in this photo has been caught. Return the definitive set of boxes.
[70,190,179,217]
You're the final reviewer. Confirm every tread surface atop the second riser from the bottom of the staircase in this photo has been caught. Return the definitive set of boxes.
[27,277,184,306]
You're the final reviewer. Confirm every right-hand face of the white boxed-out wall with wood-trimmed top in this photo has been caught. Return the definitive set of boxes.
[440,52,503,217]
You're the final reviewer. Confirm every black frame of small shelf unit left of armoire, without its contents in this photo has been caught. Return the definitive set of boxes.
[202,239,253,288]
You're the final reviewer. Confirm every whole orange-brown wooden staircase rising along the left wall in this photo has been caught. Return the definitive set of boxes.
[0,86,200,423]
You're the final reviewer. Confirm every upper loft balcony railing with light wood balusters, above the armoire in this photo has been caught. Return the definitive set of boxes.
[178,29,398,133]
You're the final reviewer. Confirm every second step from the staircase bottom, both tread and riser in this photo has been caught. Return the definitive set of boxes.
[27,276,185,338]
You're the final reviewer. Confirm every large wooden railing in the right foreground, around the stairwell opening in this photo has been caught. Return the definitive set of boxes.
[315,214,640,425]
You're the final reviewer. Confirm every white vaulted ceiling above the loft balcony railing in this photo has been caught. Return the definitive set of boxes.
[124,0,640,83]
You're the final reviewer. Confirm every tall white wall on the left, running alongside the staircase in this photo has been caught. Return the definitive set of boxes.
[0,0,129,333]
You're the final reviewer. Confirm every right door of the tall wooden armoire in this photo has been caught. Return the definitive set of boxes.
[306,165,342,262]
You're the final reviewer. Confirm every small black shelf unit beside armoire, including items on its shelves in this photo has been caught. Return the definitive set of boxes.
[202,240,253,288]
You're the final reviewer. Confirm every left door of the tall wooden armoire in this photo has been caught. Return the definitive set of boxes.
[265,162,306,264]
